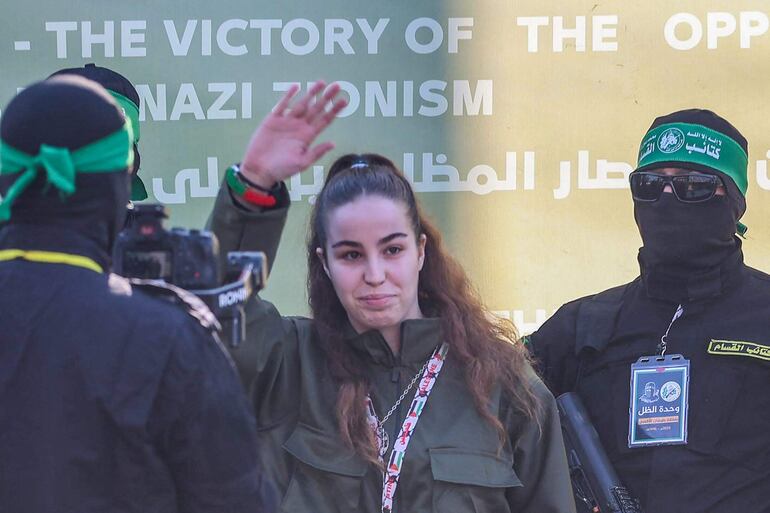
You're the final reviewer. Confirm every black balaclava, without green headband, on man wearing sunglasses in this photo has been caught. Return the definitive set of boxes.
[634,109,748,276]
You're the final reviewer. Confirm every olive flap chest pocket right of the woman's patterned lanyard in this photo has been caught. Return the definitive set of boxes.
[429,448,522,513]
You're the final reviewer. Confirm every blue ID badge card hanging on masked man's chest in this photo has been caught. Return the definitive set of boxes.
[628,354,690,448]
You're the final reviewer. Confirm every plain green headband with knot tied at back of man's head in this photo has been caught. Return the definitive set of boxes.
[0,122,134,222]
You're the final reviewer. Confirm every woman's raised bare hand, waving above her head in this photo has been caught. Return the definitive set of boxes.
[241,80,347,188]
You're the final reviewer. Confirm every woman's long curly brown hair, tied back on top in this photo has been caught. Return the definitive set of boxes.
[307,154,540,464]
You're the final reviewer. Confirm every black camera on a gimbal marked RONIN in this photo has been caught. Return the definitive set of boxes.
[113,204,267,347]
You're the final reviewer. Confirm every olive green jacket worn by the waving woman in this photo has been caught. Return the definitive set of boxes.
[209,187,575,513]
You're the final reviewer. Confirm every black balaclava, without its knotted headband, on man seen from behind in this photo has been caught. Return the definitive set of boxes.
[0,77,130,264]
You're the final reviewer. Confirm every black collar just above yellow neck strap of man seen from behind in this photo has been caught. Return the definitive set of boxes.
[0,223,111,272]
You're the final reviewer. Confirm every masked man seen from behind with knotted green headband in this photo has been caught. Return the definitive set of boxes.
[0,76,259,513]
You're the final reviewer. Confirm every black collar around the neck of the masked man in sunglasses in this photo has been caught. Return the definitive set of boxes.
[639,241,744,304]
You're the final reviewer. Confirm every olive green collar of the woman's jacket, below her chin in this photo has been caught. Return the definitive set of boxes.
[345,318,444,367]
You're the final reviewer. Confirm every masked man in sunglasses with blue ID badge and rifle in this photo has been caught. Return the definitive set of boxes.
[529,110,770,513]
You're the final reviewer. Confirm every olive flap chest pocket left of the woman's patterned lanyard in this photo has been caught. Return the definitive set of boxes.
[279,424,367,513]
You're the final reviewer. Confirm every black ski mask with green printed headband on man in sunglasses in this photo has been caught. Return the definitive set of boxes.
[634,109,748,275]
